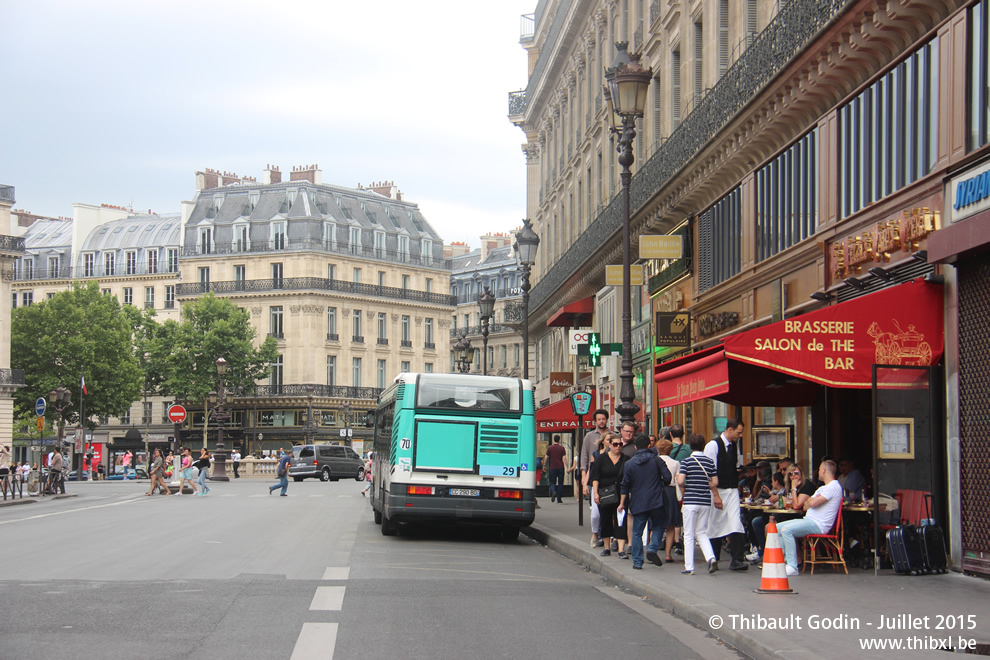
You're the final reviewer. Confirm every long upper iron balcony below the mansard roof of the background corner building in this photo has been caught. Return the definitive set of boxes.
[175,277,454,305]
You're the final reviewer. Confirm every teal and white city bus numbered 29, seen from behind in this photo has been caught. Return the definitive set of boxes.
[371,373,536,540]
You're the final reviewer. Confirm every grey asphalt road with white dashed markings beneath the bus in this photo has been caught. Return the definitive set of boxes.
[0,479,740,660]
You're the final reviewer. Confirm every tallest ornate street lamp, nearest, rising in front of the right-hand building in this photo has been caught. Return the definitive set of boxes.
[605,41,653,422]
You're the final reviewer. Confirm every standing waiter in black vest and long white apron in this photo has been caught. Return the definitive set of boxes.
[705,417,749,571]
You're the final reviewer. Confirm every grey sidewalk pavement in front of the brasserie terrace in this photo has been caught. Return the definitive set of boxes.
[523,498,990,660]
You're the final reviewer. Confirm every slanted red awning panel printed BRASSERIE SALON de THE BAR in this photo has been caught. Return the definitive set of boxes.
[725,279,944,389]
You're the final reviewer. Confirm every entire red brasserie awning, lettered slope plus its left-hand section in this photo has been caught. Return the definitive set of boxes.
[654,280,944,406]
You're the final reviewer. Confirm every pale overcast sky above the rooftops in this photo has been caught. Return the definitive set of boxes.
[0,0,536,247]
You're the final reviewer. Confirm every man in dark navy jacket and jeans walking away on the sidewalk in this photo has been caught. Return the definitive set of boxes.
[618,433,670,569]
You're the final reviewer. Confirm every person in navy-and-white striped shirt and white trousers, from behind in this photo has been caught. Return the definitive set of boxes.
[677,433,718,575]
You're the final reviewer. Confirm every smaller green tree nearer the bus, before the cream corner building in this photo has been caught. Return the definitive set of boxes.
[160,293,278,402]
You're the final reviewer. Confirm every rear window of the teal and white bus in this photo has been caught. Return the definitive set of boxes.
[416,377,522,412]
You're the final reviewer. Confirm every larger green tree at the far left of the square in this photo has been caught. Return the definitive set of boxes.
[10,281,144,424]
